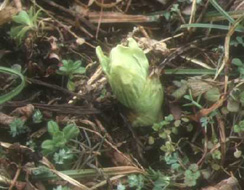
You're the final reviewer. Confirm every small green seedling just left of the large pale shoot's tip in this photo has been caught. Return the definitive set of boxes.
[57,60,86,91]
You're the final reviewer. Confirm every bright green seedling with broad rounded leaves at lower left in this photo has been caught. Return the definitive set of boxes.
[42,121,80,155]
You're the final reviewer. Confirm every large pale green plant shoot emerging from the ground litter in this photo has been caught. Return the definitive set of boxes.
[96,38,163,126]
